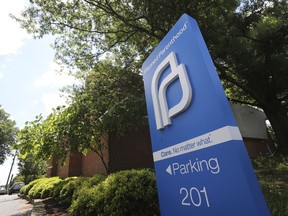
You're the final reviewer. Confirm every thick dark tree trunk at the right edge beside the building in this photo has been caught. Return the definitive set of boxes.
[262,101,288,153]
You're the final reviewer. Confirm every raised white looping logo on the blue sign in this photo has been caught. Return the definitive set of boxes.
[151,52,192,130]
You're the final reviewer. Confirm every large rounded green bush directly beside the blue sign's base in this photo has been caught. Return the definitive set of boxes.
[69,169,159,216]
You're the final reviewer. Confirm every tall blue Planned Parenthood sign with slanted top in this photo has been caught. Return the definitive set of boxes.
[142,14,270,216]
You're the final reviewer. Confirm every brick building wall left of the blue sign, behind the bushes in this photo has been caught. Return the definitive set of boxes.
[47,127,154,178]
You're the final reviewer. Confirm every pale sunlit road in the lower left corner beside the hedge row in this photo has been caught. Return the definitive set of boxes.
[0,194,32,216]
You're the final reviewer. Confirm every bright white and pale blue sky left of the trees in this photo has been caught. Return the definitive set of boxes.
[0,0,74,185]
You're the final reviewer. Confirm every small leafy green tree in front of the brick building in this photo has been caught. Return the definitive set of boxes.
[16,60,147,173]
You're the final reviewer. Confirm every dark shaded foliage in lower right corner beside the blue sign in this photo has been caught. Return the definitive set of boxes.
[252,155,288,216]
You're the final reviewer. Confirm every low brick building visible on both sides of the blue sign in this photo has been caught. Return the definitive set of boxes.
[47,103,275,178]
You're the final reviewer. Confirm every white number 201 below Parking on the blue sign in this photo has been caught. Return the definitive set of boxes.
[180,187,210,207]
